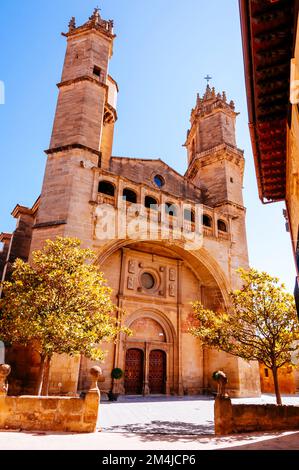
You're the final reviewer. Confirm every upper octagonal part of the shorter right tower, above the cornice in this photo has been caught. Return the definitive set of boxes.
[185,85,244,206]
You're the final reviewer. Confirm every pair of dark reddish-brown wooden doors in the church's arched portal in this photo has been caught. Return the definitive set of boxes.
[125,348,166,395]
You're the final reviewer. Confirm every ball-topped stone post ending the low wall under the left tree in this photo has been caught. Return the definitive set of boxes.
[83,366,103,432]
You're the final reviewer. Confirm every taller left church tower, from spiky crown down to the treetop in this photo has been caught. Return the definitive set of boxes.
[32,8,118,249]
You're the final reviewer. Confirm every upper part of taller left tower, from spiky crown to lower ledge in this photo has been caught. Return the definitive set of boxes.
[47,8,117,167]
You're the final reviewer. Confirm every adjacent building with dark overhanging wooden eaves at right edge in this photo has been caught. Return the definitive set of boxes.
[239,0,299,313]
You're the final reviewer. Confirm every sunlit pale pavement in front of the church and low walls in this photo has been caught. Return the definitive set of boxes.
[0,395,299,450]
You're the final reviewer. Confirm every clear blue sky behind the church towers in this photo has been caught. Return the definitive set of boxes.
[0,0,295,291]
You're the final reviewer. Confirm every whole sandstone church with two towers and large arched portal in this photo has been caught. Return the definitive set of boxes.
[0,10,260,396]
